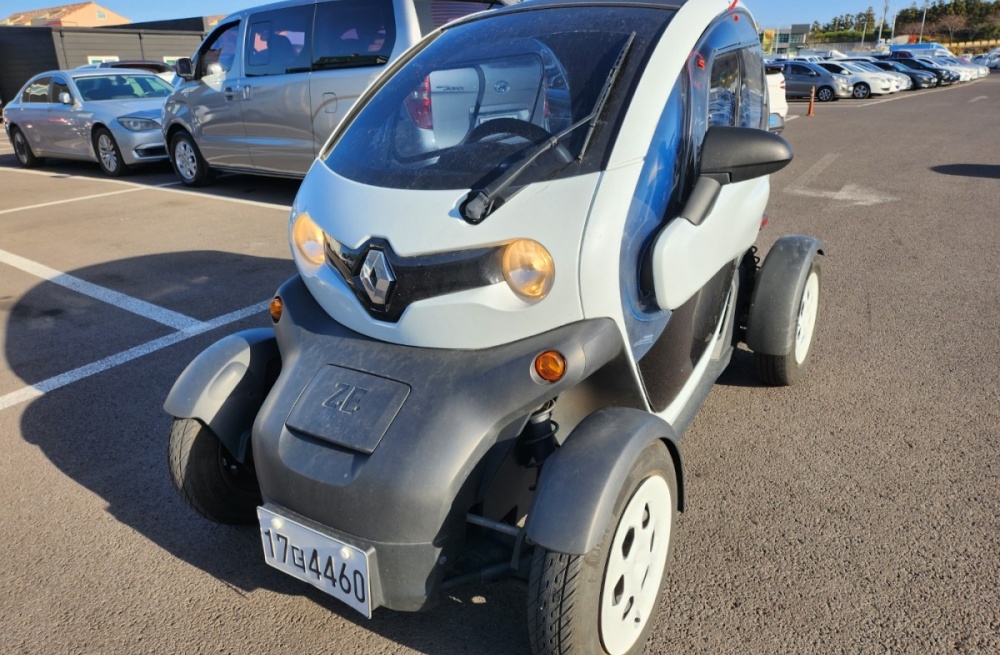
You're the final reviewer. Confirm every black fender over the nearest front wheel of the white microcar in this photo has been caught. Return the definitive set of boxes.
[525,407,684,555]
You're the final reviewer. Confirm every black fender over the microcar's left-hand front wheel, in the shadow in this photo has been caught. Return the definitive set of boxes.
[163,328,281,463]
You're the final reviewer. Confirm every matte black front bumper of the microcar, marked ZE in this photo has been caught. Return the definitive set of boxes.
[252,277,622,611]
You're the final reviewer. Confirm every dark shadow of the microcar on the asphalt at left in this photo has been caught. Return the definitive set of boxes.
[3,251,528,655]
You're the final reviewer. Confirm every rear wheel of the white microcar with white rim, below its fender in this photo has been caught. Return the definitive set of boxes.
[754,259,822,387]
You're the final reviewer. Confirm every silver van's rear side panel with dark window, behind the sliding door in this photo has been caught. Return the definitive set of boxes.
[309,0,398,156]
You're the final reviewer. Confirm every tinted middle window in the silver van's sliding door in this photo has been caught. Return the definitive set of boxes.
[244,5,313,77]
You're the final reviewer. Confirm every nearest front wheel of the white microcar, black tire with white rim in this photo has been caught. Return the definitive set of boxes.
[527,441,677,655]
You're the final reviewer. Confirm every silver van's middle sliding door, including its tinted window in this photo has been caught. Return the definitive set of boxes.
[240,4,315,175]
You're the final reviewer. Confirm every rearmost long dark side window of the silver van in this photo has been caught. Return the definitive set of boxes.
[313,0,396,69]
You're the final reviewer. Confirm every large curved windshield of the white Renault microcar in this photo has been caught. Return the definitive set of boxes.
[321,7,673,189]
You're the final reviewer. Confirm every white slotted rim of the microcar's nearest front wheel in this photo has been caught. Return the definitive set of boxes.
[600,475,673,655]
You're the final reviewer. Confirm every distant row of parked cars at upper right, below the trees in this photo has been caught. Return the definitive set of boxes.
[768,51,990,107]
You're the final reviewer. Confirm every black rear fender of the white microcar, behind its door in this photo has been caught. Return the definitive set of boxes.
[746,235,824,356]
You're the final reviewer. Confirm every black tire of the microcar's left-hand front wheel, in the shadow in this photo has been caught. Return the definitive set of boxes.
[169,418,261,525]
